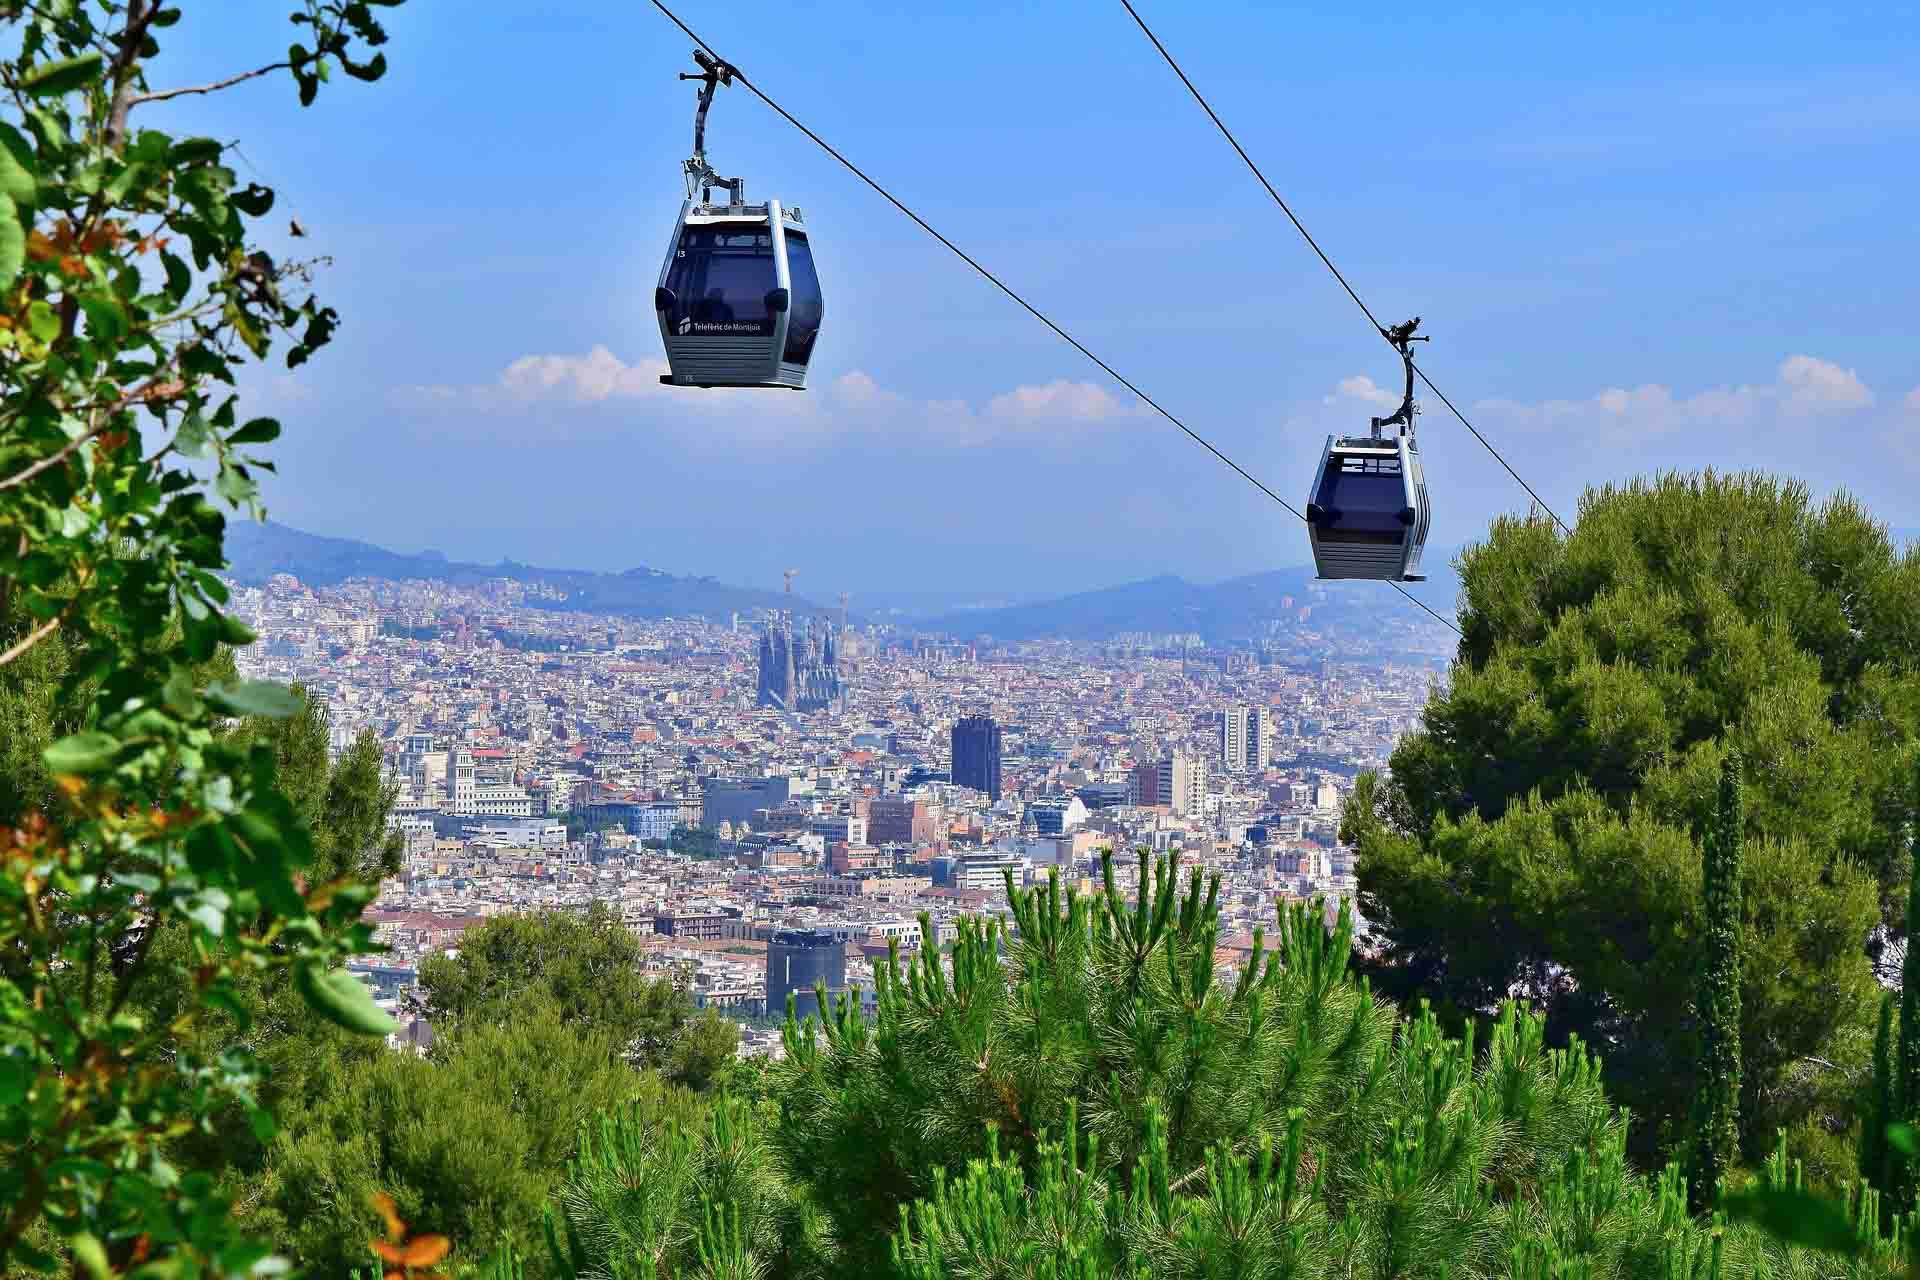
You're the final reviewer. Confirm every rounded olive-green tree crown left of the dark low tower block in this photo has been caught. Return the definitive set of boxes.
[420,902,693,1065]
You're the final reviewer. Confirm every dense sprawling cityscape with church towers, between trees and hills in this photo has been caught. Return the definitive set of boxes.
[234,574,1444,1054]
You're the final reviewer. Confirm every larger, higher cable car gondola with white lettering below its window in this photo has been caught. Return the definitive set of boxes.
[653,50,826,391]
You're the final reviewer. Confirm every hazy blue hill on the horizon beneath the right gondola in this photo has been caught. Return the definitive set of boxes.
[918,564,1459,645]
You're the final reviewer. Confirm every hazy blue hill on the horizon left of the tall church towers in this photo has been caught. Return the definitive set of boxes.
[227,520,828,620]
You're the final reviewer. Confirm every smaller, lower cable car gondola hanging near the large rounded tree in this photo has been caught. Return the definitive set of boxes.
[1308,317,1432,581]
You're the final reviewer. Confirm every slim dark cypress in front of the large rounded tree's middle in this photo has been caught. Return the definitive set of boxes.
[1690,752,1743,1205]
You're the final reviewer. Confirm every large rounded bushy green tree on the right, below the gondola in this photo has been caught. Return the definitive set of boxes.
[1344,472,1920,1157]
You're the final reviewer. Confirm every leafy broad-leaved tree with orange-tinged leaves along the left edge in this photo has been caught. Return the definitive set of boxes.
[0,0,401,1278]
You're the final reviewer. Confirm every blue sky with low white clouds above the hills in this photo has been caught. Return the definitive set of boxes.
[146,0,1920,606]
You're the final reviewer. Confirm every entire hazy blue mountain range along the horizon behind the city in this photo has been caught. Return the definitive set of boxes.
[227,520,1459,643]
